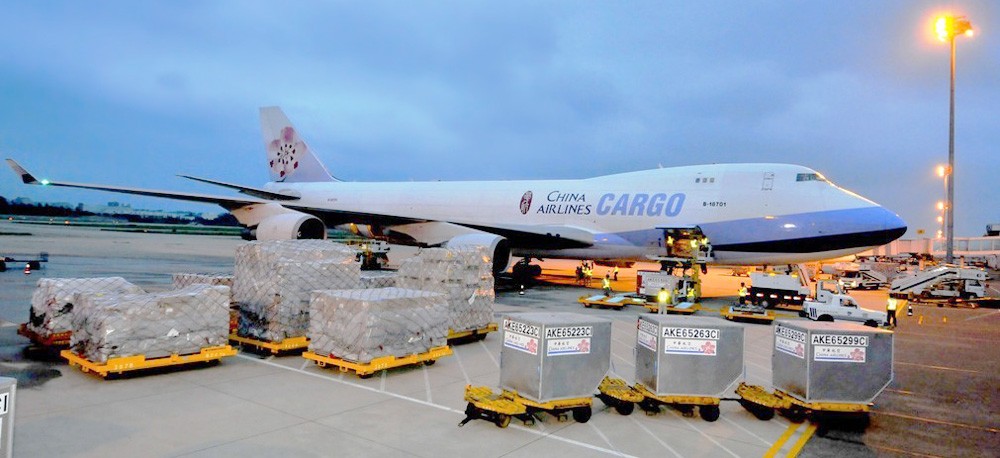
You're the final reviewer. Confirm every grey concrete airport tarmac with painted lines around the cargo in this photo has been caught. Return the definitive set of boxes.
[0,223,1000,457]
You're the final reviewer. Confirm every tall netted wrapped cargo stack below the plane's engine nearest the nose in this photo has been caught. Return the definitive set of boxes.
[396,247,495,332]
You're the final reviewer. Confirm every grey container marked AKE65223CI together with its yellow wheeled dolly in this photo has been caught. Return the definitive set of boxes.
[459,313,611,428]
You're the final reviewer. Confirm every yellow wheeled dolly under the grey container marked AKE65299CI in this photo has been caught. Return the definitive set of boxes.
[736,382,871,426]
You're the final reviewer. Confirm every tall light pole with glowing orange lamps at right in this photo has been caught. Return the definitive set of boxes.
[934,16,973,264]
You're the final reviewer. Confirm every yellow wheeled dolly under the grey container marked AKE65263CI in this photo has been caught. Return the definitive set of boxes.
[598,377,722,421]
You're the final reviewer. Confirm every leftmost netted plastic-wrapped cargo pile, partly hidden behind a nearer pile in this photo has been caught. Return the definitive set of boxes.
[28,277,145,336]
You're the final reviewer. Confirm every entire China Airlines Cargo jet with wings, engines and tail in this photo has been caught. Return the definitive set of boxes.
[7,107,906,271]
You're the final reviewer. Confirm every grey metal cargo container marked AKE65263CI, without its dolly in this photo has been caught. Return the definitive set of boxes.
[635,315,744,397]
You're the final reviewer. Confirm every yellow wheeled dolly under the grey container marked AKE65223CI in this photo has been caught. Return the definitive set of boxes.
[458,385,594,428]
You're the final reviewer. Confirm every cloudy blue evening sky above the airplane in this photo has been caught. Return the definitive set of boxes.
[0,0,1000,237]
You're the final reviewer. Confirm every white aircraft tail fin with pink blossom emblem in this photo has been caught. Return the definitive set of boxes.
[260,107,338,183]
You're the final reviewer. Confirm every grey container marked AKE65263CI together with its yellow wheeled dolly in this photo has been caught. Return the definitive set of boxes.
[597,315,744,421]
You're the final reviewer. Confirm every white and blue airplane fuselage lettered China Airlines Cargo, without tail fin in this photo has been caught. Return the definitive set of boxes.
[265,164,905,264]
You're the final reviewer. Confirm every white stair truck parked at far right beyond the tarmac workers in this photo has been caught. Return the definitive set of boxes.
[889,266,988,299]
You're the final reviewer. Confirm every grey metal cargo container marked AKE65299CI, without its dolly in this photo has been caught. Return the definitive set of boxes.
[771,320,893,404]
